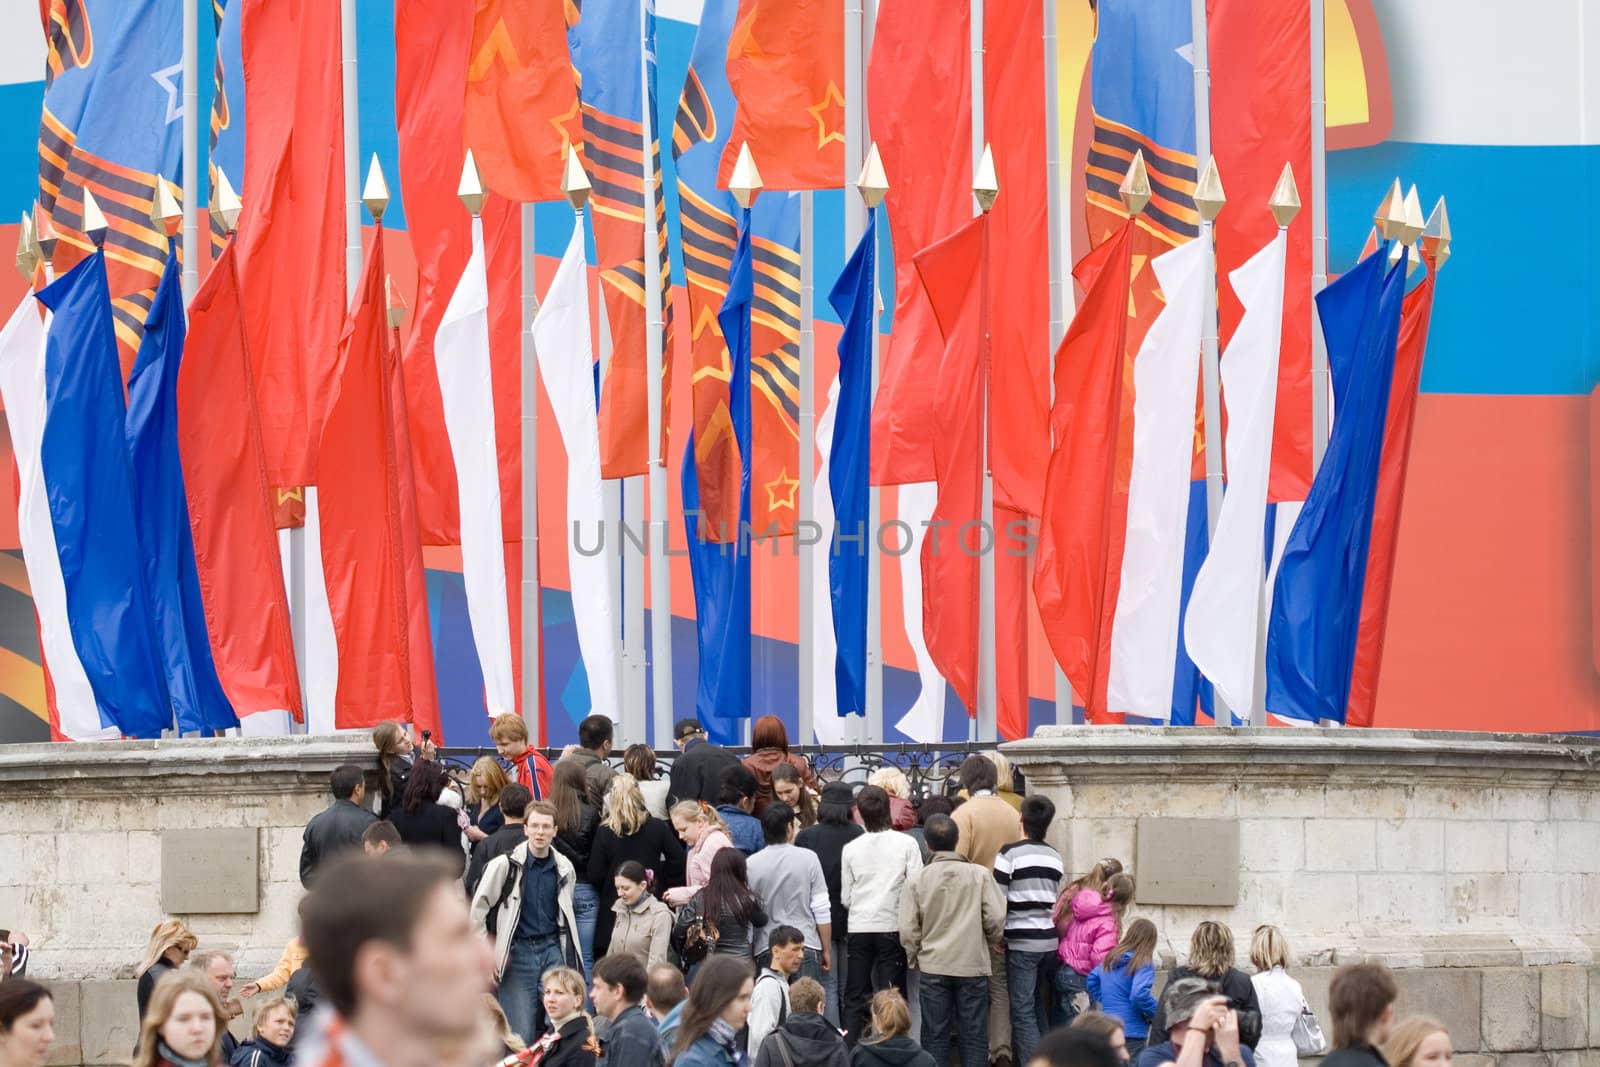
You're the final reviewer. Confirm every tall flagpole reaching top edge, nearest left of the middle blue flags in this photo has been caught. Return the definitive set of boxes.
[638,0,672,749]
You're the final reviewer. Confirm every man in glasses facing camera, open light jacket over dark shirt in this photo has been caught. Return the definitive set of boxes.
[472,800,582,1045]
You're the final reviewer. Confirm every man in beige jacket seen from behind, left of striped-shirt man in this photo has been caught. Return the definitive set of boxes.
[899,816,1005,1067]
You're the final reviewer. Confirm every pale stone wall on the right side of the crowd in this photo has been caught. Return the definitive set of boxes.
[1003,726,1600,1067]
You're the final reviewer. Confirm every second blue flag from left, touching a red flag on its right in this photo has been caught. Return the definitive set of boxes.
[126,251,238,731]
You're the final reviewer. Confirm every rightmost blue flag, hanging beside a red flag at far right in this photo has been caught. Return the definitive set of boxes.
[1267,246,1405,723]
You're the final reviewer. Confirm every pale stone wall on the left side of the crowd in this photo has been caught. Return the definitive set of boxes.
[0,737,373,1065]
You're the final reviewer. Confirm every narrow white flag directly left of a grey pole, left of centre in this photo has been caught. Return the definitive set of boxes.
[434,222,512,715]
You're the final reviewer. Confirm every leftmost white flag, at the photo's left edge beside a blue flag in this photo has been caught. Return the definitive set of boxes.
[0,293,111,741]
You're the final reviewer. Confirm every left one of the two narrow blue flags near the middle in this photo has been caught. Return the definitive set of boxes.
[683,210,755,744]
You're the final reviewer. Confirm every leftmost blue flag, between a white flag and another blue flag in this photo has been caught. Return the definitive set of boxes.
[38,253,173,737]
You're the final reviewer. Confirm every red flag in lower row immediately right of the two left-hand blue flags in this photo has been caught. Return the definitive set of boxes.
[178,242,304,721]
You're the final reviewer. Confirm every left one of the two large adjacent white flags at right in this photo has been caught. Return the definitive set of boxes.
[1106,233,1211,718]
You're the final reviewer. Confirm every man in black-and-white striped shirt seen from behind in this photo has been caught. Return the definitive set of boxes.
[995,797,1062,1064]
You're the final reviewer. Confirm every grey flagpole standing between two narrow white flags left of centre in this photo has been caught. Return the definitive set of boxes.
[522,203,544,744]
